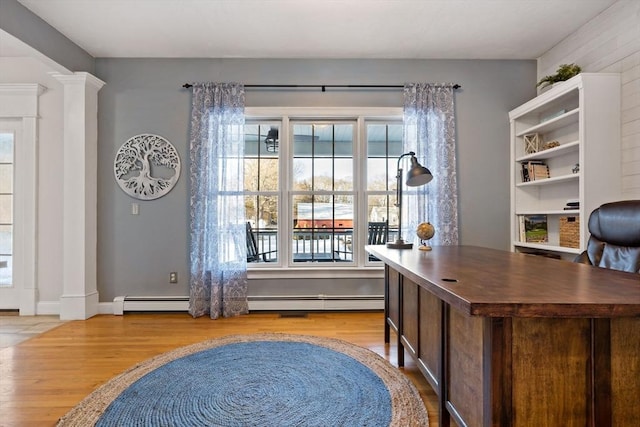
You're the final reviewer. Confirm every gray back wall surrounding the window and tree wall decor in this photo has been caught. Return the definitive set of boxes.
[95,59,536,301]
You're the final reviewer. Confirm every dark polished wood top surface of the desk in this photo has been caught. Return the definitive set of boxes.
[366,246,640,317]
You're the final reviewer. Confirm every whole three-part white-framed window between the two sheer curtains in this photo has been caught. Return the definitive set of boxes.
[244,112,402,268]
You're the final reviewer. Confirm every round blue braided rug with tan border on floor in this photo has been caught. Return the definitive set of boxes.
[58,334,428,427]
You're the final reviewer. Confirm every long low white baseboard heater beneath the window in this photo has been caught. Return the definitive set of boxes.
[113,295,384,316]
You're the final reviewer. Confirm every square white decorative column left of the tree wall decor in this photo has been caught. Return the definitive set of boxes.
[53,73,104,320]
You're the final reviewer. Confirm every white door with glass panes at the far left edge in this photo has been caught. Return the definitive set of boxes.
[0,119,20,310]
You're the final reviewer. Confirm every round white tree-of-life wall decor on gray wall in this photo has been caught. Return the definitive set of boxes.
[113,134,180,200]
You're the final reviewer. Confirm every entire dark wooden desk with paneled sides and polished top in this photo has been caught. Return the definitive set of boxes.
[367,246,640,427]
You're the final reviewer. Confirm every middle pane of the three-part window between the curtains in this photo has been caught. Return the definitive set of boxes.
[290,121,356,262]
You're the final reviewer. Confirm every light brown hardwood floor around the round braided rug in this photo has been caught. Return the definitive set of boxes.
[0,312,438,427]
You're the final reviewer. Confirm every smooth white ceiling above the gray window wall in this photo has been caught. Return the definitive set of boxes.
[11,0,616,59]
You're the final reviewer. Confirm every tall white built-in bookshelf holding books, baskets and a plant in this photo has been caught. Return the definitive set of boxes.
[509,73,620,260]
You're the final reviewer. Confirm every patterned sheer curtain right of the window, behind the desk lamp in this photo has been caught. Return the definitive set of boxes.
[402,83,458,245]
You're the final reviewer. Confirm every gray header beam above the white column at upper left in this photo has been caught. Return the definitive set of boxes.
[0,0,94,73]
